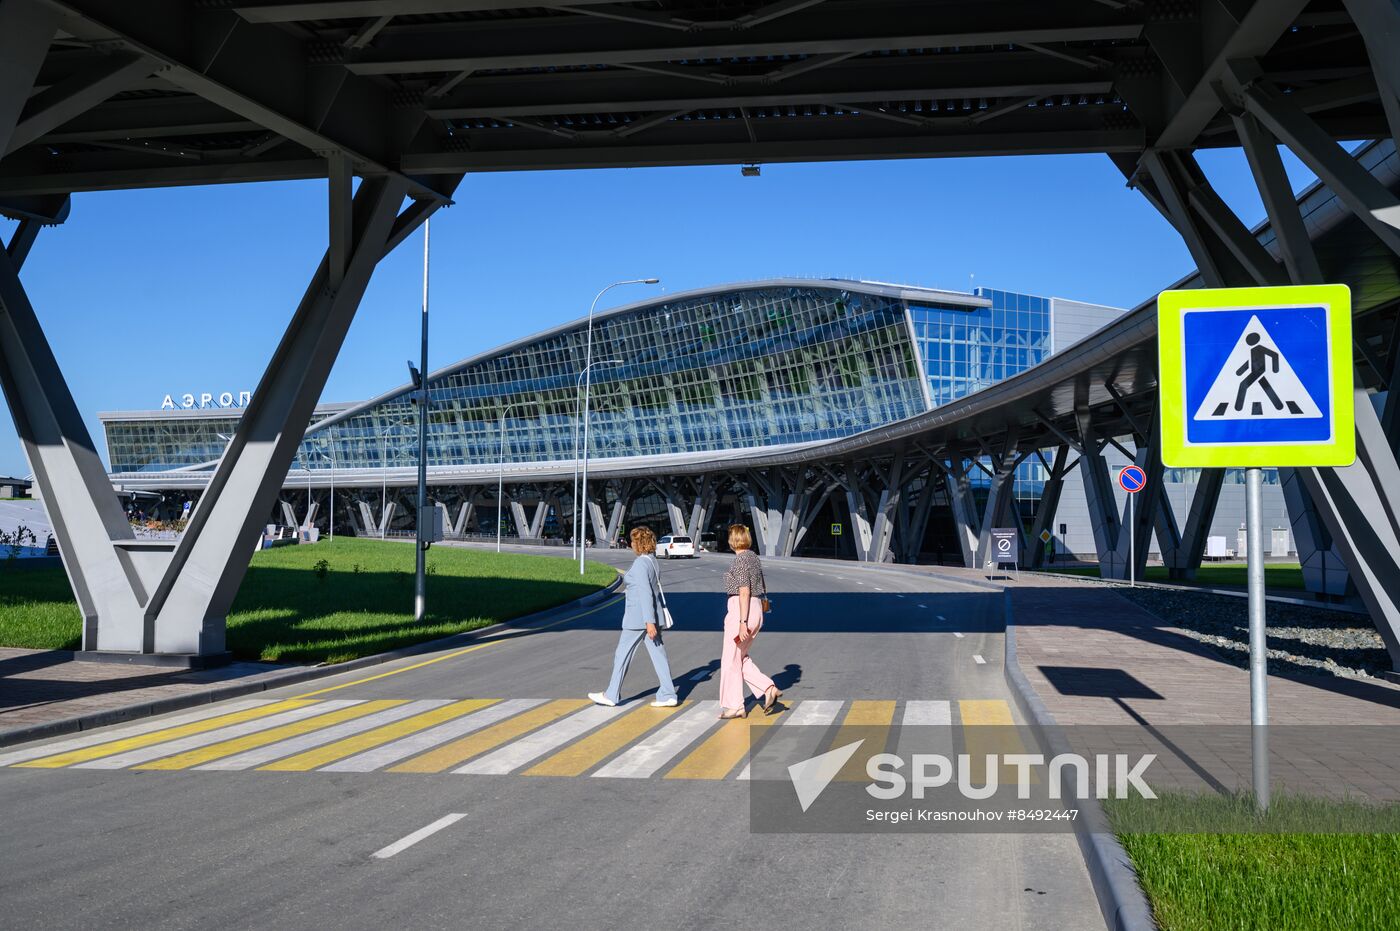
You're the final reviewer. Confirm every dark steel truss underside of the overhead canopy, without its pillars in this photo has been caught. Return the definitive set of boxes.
[0,0,1386,218]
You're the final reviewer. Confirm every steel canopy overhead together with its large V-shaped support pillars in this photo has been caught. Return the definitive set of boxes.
[0,0,1400,663]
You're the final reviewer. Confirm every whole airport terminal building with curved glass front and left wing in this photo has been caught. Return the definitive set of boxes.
[99,279,1282,559]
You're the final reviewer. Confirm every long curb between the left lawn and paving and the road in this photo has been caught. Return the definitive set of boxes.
[0,573,622,746]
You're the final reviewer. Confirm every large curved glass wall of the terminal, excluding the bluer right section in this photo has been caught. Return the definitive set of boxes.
[307,286,925,469]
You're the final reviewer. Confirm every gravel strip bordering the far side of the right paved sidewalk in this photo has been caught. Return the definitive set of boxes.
[1116,588,1390,679]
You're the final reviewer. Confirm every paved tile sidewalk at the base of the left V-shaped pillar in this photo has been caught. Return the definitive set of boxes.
[0,648,288,731]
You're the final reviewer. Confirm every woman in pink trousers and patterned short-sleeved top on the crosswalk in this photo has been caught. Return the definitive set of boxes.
[720,524,783,718]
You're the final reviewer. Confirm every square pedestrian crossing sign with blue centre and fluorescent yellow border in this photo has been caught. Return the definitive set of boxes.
[1156,284,1357,468]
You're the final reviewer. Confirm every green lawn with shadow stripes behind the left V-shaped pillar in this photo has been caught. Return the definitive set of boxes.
[0,538,616,662]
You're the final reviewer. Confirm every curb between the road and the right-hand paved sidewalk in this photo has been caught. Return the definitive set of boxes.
[1002,589,1156,931]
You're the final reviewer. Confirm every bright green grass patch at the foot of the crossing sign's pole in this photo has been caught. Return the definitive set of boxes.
[1106,795,1400,931]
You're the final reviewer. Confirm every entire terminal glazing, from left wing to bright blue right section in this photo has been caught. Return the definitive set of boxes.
[104,280,1080,476]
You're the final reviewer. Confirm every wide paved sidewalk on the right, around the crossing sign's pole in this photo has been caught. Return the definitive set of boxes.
[985,577,1400,802]
